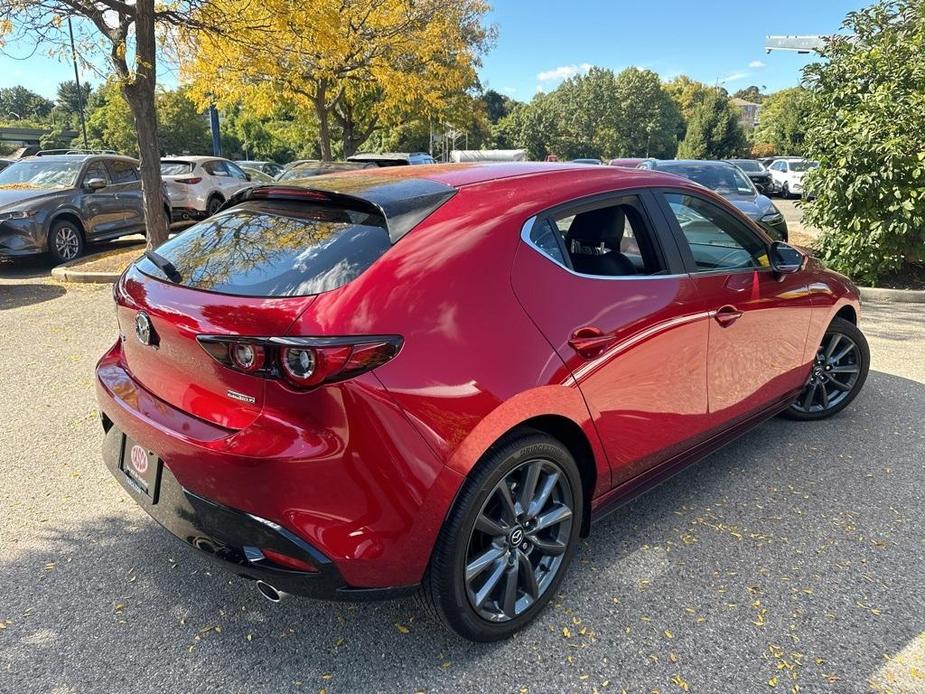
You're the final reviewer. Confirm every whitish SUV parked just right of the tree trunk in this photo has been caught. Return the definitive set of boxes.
[161,156,254,221]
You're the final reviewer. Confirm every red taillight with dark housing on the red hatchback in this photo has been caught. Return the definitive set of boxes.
[198,335,402,388]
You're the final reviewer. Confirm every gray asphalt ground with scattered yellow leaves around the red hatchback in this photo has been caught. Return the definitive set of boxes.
[0,263,925,694]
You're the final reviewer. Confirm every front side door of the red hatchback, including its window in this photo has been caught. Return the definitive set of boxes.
[657,190,812,429]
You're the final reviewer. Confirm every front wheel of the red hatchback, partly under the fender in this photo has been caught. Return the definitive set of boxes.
[783,318,870,421]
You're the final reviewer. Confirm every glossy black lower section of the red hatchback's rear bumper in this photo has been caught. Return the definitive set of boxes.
[103,418,417,601]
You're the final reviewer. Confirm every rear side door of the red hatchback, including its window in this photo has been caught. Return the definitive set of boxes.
[512,191,709,486]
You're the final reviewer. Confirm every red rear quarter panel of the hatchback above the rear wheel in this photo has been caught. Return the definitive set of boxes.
[284,174,610,500]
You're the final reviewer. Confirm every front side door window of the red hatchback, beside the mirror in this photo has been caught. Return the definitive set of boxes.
[665,193,769,272]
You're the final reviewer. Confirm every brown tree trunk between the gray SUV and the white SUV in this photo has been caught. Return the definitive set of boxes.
[122,0,169,249]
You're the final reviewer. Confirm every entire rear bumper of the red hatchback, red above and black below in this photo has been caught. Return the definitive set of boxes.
[96,342,464,599]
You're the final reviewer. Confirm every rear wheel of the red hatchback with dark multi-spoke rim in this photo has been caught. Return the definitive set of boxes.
[421,433,584,642]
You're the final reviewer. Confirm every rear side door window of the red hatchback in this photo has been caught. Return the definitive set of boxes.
[530,195,665,277]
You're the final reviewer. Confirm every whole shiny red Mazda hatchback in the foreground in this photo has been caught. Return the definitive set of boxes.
[96,164,869,641]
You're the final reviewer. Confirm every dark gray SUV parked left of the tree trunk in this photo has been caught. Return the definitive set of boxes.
[0,154,169,262]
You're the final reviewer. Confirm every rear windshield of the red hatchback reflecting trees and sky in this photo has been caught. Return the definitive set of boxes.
[138,201,391,297]
